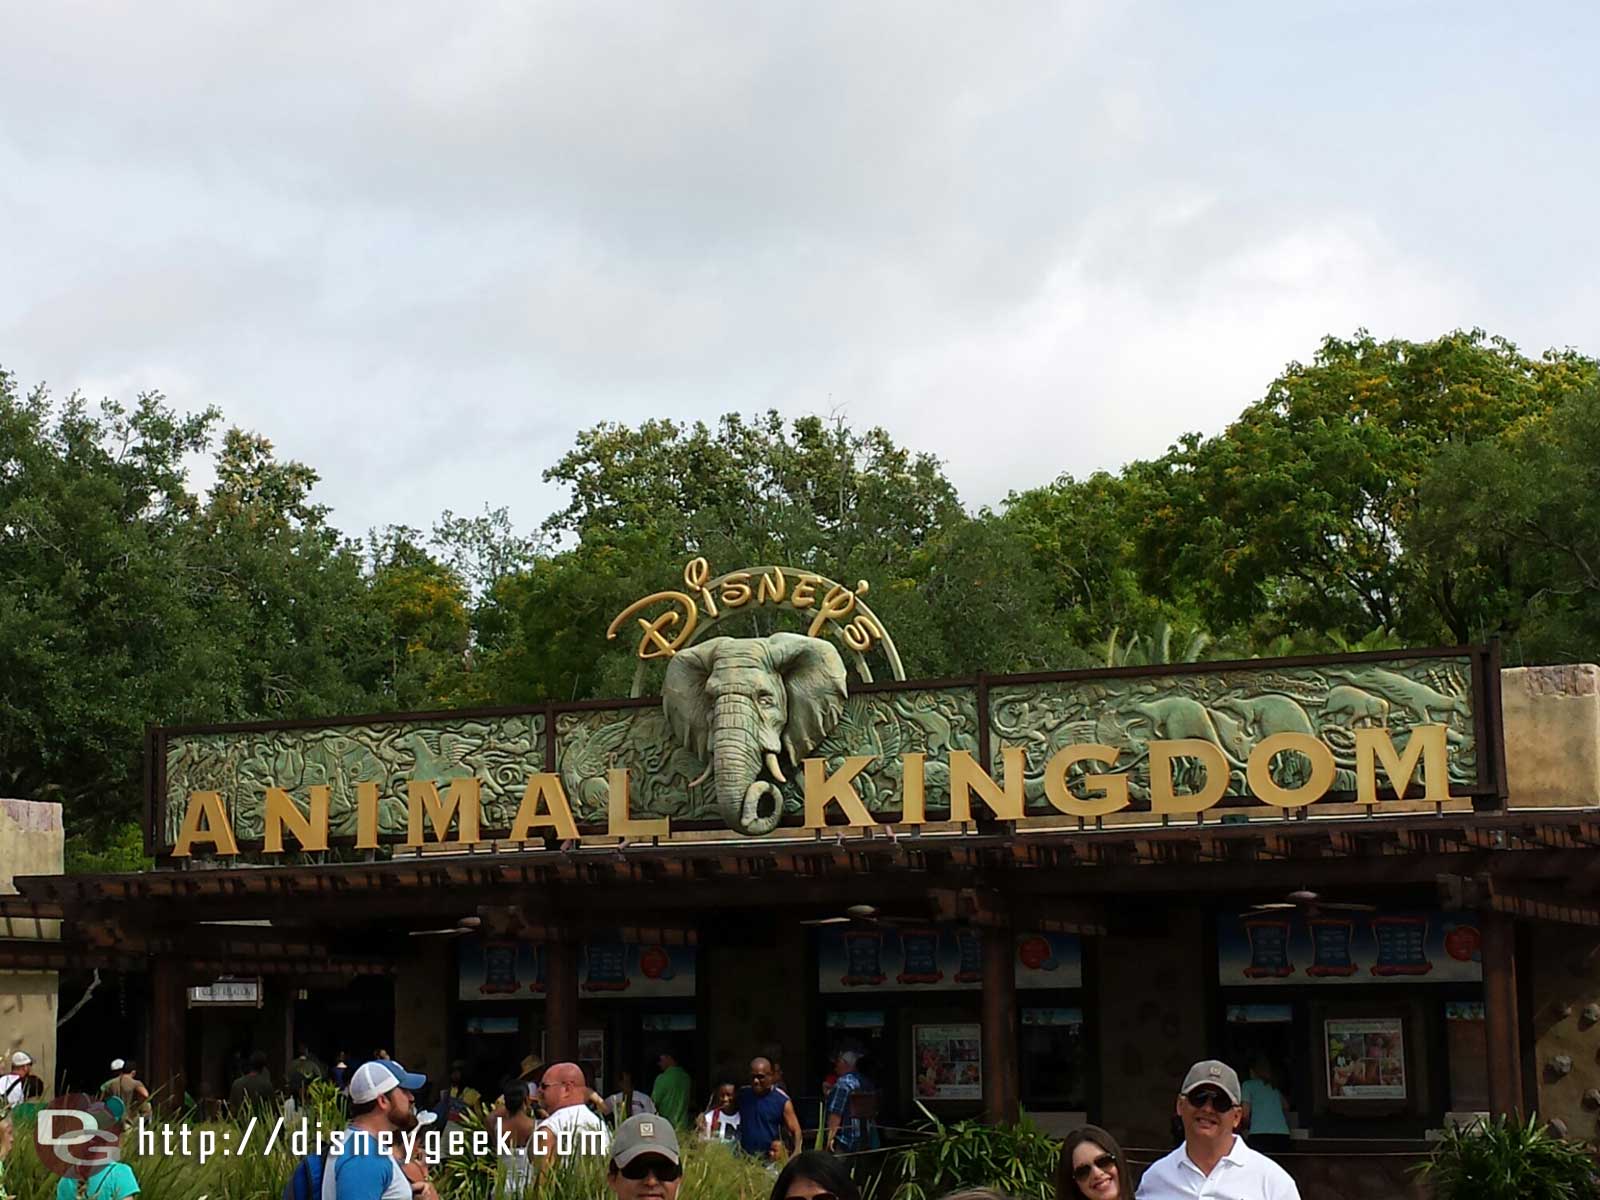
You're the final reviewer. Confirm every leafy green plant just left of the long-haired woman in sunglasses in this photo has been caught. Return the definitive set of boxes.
[888,1102,1061,1200]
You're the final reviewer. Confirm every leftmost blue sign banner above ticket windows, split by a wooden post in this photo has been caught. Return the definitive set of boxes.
[458,938,694,1000]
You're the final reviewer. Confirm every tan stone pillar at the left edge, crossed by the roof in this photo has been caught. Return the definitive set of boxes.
[0,800,62,1094]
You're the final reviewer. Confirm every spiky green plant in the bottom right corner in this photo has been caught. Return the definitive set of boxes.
[1416,1114,1600,1200]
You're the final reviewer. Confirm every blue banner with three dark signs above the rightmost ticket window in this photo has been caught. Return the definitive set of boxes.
[1216,906,1483,987]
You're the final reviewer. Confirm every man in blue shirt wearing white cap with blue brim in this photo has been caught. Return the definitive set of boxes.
[322,1059,438,1200]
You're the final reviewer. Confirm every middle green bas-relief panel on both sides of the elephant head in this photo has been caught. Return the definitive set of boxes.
[555,688,978,824]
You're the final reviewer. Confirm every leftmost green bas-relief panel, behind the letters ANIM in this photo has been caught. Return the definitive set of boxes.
[165,712,544,845]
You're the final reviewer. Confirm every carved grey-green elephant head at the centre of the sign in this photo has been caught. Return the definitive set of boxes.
[661,634,845,834]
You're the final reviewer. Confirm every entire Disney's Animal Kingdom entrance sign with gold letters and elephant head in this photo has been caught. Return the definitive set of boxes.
[147,614,1504,861]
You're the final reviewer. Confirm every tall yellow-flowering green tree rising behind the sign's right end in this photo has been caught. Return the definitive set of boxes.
[1130,330,1597,640]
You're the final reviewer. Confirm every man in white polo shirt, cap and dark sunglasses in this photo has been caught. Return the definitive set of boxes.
[1138,1059,1299,1200]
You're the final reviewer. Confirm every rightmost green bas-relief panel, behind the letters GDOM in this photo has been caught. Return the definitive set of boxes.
[992,656,1478,811]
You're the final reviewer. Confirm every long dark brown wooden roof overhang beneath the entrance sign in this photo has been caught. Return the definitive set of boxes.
[0,808,1600,973]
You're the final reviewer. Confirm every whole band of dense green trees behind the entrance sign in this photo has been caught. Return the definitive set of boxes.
[0,331,1600,870]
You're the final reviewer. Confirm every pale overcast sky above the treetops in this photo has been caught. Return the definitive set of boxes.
[0,0,1600,533]
